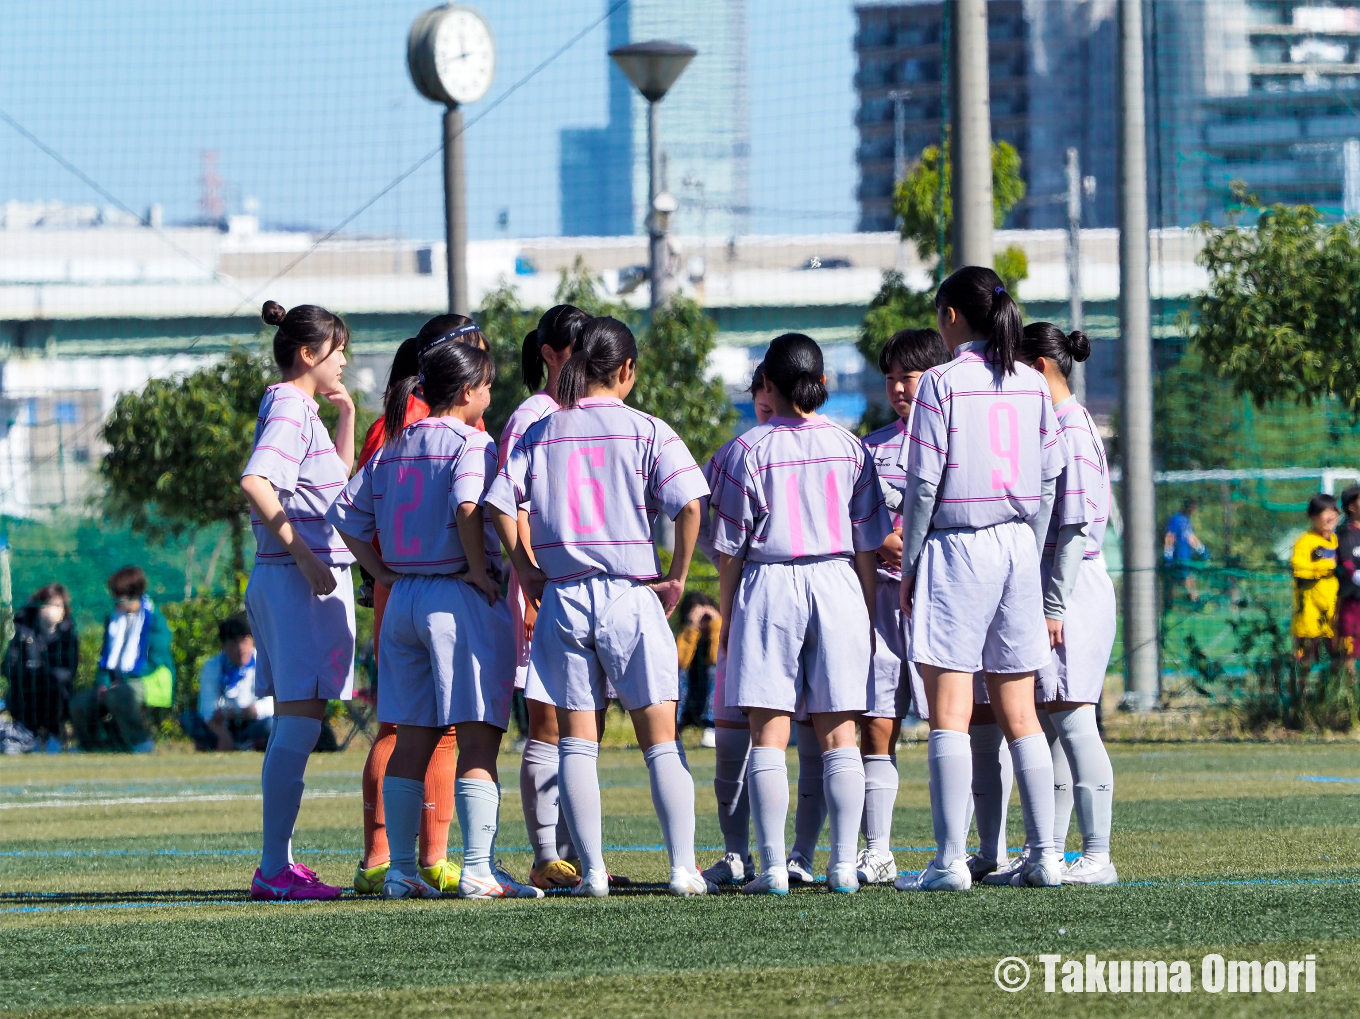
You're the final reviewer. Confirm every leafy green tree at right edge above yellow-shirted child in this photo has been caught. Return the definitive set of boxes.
[1194,193,1360,415]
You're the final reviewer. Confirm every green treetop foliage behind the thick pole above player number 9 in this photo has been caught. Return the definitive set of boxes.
[892,139,1030,290]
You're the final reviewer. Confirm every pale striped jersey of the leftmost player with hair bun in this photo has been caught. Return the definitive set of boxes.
[241,382,354,566]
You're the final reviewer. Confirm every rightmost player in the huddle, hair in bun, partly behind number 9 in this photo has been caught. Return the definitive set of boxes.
[1020,322,1119,884]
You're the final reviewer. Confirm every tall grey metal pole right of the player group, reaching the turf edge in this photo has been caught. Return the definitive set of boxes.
[1118,0,1160,712]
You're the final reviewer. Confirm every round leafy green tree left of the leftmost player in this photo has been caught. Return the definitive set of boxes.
[99,348,273,571]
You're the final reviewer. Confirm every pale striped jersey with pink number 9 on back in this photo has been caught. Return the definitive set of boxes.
[898,340,1068,529]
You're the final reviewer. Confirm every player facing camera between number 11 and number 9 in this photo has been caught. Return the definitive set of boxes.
[855,329,949,884]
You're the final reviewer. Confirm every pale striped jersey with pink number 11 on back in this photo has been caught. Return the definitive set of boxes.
[713,415,892,563]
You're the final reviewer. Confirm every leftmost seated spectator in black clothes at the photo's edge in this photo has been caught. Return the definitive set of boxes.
[0,584,80,754]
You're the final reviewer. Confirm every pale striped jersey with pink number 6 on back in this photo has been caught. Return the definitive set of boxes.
[487,397,709,581]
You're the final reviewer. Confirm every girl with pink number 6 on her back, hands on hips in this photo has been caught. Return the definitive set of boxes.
[487,318,713,898]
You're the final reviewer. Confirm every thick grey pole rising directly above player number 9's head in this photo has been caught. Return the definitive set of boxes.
[948,0,993,267]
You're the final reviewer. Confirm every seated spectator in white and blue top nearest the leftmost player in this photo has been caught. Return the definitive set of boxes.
[180,612,273,751]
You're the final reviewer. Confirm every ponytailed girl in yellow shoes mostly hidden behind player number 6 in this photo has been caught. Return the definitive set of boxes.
[499,305,590,888]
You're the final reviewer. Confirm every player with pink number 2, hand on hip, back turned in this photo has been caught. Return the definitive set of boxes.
[326,322,543,899]
